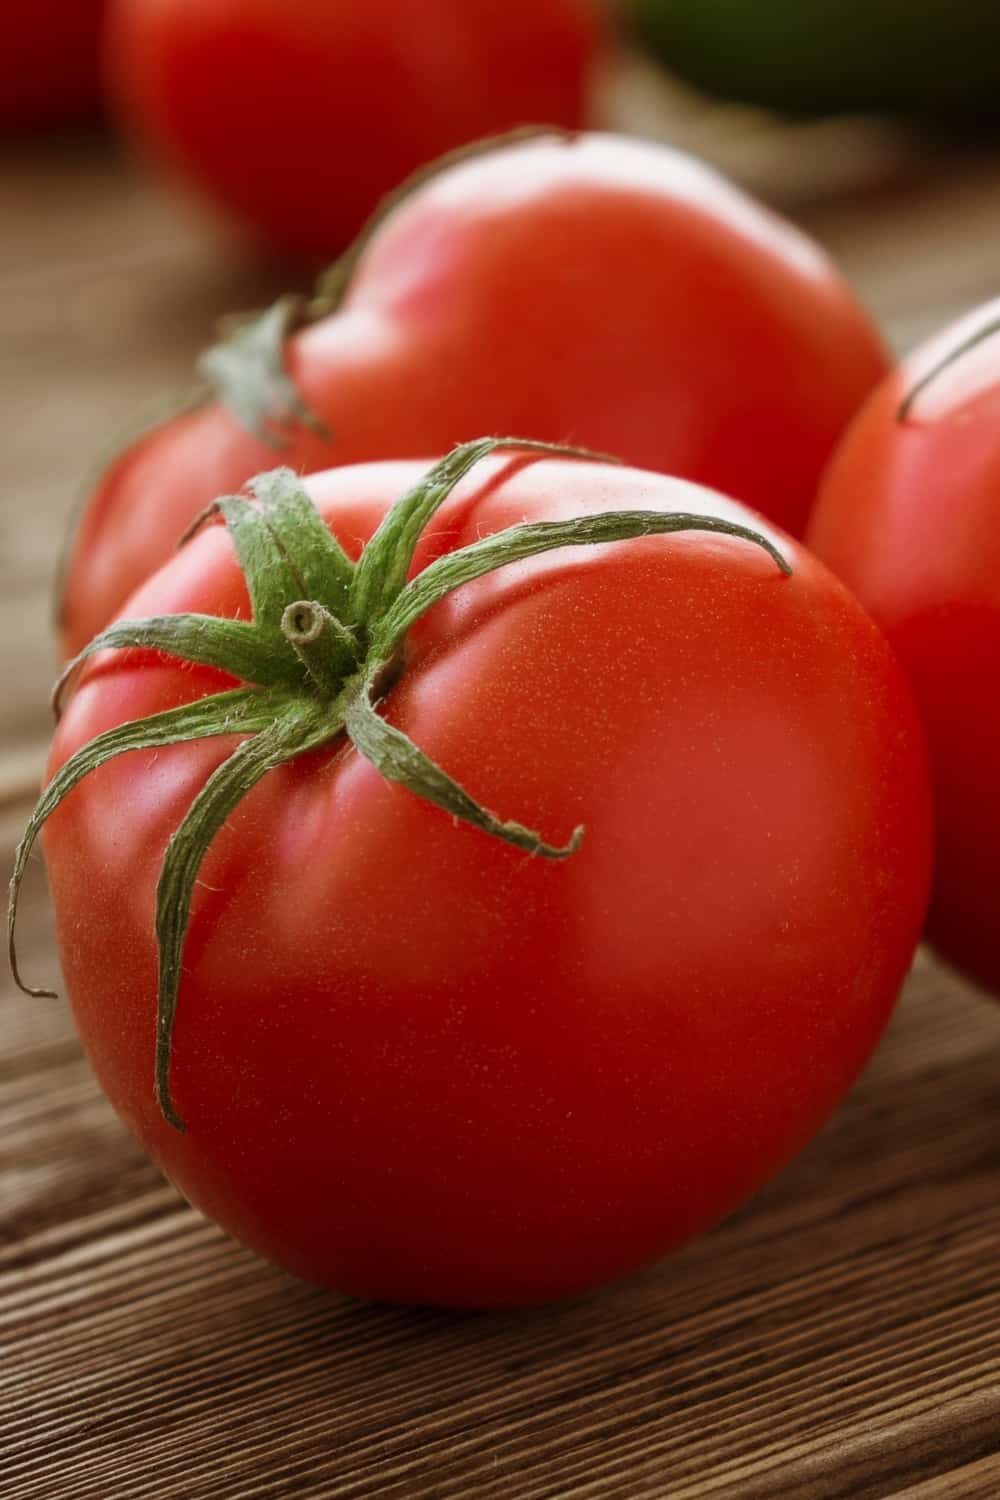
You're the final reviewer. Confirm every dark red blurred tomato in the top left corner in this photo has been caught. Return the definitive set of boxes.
[0,0,106,135]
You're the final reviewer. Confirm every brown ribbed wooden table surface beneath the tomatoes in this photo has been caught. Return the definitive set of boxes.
[0,66,1000,1500]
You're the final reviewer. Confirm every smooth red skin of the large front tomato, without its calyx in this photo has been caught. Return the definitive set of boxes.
[45,462,931,1307]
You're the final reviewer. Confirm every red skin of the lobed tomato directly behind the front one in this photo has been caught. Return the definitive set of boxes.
[61,135,886,654]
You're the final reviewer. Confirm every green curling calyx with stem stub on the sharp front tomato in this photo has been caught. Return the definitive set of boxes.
[7,438,790,1130]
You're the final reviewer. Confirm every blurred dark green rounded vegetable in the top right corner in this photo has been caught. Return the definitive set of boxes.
[627,0,1000,117]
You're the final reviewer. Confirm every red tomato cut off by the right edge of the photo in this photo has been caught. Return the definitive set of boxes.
[810,299,1000,992]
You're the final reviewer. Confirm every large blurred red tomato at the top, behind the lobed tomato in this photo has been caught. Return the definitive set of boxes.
[106,0,603,263]
